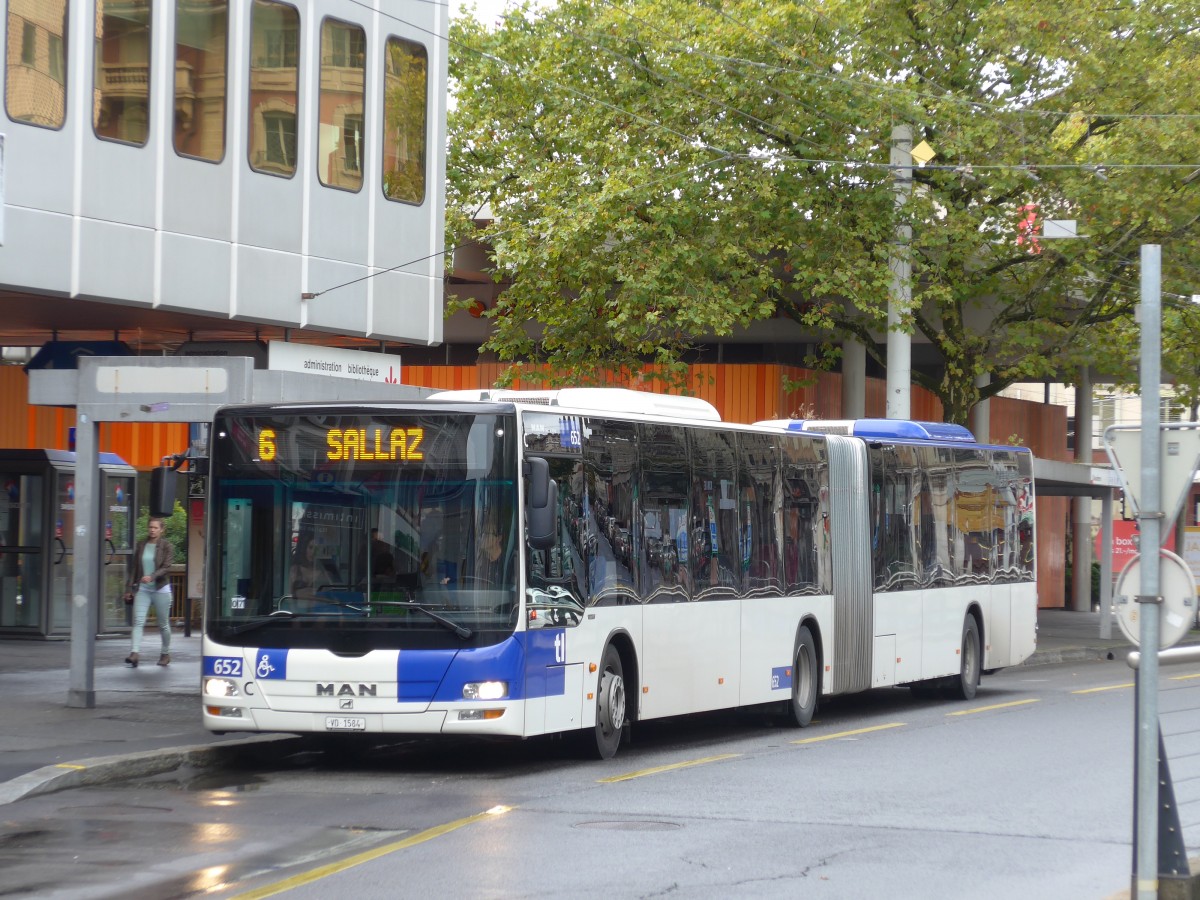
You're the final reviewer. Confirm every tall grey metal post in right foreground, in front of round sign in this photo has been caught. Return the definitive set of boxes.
[1133,244,1163,900]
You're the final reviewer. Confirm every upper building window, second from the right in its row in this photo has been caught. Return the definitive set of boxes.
[317,19,366,191]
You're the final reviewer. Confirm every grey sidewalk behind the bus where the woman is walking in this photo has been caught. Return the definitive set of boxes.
[0,610,1171,805]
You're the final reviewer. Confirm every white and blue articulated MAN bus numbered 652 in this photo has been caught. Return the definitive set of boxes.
[203,389,1037,758]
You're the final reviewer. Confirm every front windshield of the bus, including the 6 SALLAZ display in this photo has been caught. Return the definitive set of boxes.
[205,407,520,653]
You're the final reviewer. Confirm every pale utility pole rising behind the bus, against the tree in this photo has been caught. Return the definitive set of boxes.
[887,125,912,419]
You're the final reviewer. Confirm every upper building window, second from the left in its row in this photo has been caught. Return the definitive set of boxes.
[91,4,152,146]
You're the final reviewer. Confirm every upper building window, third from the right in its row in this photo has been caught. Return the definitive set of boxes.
[246,0,300,176]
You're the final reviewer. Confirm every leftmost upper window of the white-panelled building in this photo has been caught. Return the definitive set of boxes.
[5,0,68,128]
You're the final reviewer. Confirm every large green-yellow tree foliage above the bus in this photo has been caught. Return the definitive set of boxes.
[448,0,1200,421]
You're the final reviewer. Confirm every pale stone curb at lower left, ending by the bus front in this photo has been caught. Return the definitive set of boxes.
[0,734,296,806]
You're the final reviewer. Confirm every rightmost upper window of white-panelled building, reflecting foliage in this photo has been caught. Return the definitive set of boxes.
[383,37,428,203]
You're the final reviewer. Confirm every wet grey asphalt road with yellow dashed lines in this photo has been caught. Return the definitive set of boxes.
[0,661,1200,900]
